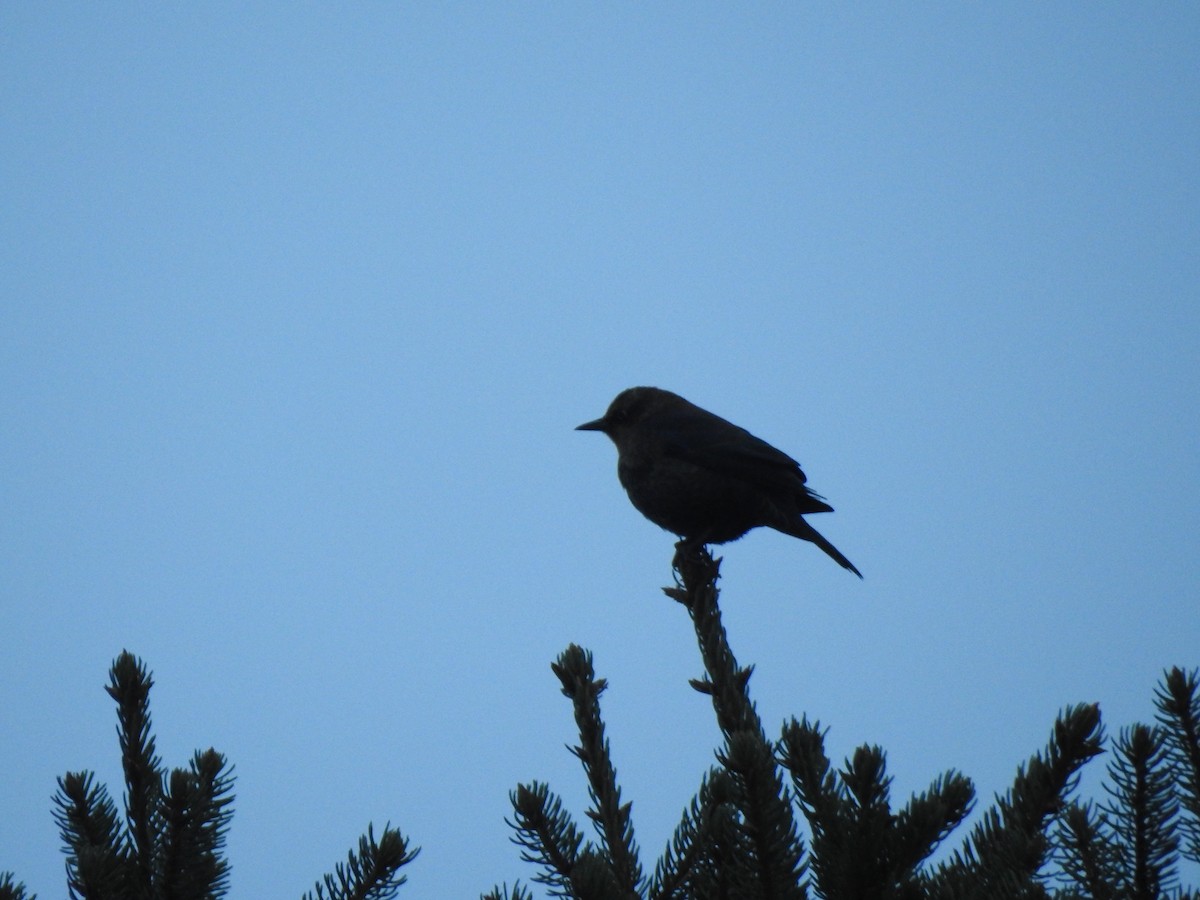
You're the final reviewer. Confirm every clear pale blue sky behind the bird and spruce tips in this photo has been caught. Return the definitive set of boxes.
[0,2,1200,898]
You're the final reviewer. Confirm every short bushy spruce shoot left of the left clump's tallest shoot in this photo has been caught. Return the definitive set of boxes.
[54,772,133,900]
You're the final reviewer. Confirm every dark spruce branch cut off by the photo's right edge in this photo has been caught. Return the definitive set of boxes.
[1154,666,1200,863]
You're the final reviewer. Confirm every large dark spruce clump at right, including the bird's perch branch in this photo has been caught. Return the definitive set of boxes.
[484,542,1200,900]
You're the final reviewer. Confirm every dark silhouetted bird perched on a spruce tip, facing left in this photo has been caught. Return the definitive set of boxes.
[576,388,863,578]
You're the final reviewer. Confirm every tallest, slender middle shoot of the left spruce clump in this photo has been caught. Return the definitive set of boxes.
[104,650,163,900]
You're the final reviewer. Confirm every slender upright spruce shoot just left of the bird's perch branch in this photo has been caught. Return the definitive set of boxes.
[551,643,643,898]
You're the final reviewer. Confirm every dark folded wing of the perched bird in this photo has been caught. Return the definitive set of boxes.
[654,407,833,512]
